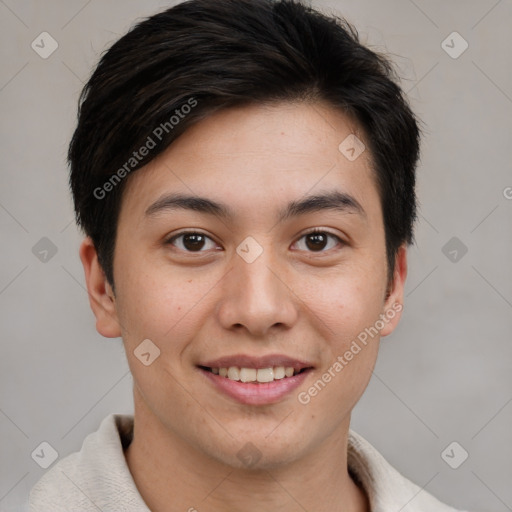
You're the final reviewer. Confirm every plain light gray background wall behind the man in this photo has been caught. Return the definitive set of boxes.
[0,0,512,512]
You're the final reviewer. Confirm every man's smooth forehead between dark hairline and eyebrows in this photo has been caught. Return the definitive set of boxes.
[118,103,376,224]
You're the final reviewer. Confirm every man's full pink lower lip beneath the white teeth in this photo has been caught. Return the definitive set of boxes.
[199,368,311,405]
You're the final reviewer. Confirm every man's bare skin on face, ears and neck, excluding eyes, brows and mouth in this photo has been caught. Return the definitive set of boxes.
[80,103,407,512]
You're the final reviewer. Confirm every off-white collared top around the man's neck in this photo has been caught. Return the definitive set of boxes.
[29,414,468,512]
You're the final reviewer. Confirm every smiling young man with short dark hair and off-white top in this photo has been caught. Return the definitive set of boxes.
[30,0,468,512]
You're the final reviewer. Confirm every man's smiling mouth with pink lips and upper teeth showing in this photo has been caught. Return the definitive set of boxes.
[197,355,314,405]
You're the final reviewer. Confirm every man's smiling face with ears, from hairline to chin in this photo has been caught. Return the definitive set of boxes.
[81,103,406,468]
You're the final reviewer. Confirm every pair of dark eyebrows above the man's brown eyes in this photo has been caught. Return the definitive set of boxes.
[145,190,366,222]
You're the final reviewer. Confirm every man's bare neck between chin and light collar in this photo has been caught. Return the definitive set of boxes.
[125,390,370,512]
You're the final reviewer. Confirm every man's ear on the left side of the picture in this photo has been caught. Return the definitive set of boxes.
[79,237,121,338]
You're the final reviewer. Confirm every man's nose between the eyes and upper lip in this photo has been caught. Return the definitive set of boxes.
[217,242,298,338]
